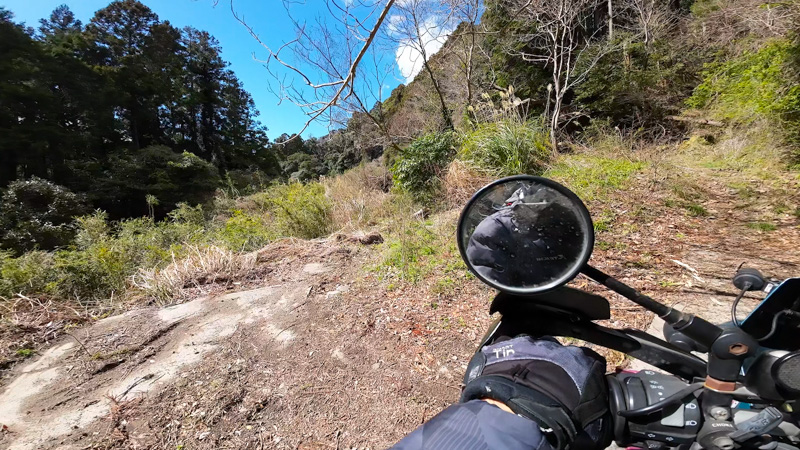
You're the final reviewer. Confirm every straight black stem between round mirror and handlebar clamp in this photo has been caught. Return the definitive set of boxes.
[581,264,722,347]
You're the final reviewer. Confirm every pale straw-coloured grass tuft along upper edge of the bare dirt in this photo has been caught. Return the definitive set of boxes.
[133,245,257,306]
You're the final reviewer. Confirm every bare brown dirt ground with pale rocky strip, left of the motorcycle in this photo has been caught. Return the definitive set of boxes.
[0,239,488,449]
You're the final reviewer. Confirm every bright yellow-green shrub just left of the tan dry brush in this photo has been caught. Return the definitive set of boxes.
[252,183,332,239]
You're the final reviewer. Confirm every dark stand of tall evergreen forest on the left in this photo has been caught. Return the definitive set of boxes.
[0,0,376,250]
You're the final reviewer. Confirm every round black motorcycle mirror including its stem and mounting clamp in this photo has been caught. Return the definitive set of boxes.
[457,175,740,376]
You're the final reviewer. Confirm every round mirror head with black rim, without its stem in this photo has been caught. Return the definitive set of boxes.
[458,175,594,295]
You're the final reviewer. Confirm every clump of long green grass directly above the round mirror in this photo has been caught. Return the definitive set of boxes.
[459,120,551,176]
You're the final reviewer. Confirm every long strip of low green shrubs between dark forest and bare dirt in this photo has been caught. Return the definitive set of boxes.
[0,183,331,304]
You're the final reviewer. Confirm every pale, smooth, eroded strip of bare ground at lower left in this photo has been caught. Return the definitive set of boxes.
[0,282,304,449]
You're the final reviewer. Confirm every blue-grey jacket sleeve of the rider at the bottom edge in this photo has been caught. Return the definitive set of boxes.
[392,400,552,450]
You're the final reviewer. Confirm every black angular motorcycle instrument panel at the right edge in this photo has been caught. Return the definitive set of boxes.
[741,278,800,351]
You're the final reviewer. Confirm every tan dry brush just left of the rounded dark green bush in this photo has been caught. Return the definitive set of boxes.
[322,161,392,231]
